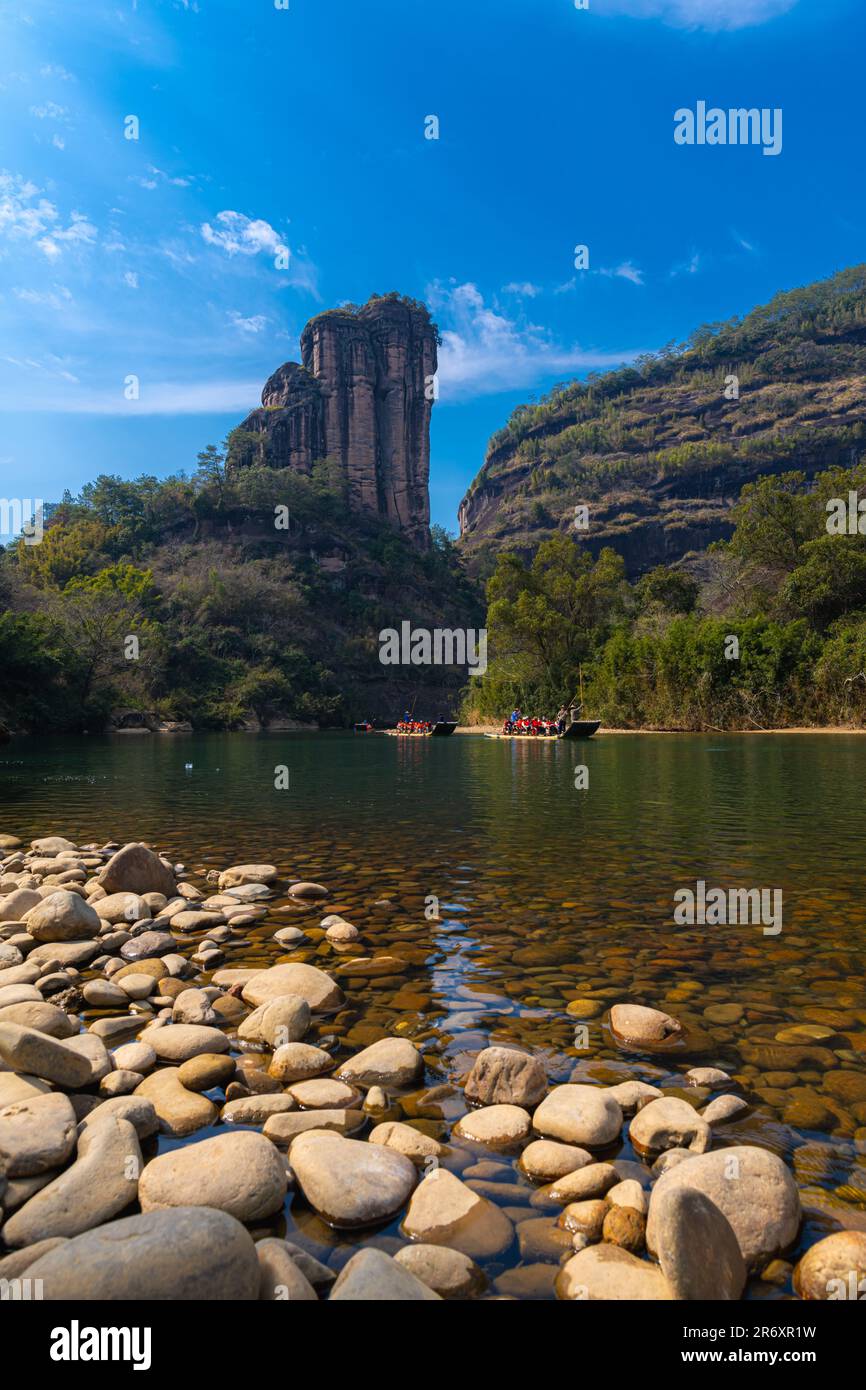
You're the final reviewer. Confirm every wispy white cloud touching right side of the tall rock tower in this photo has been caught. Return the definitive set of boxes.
[427,282,637,400]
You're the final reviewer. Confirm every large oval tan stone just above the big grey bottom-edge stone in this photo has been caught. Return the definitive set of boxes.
[139,1130,288,1222]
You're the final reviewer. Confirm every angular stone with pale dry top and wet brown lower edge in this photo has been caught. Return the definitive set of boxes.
[400,1168,514,1259]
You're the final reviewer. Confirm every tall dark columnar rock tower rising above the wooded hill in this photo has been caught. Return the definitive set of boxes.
[235,295,438,546]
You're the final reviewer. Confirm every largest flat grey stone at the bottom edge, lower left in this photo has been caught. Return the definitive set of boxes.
[24,1207,260,1302]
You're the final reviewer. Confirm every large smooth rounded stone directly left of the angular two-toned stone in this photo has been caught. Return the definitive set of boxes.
[289,1133,416,1229]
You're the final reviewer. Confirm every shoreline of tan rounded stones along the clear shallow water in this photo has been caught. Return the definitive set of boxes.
[0,835,866,1301]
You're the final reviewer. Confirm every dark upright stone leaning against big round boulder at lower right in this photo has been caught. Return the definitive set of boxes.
[653,1187,746,1301]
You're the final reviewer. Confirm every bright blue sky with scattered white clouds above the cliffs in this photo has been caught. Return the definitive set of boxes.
[0,0,866,530]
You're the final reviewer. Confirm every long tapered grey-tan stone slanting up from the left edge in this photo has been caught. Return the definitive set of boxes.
[3,1116,142,1258]
